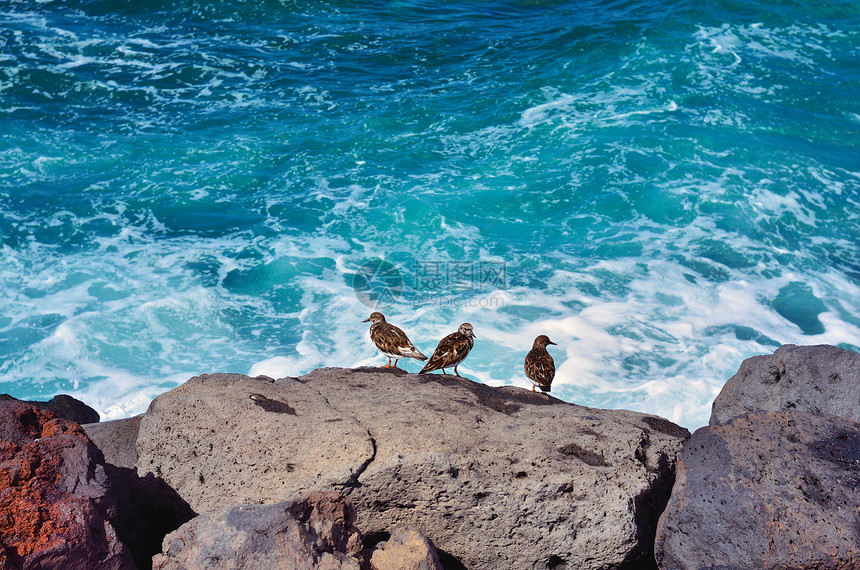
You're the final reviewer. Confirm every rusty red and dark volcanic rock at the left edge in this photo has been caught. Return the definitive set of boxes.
[0,400,134,570]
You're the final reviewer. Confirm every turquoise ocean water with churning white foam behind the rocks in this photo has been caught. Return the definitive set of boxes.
[0,0,860,428]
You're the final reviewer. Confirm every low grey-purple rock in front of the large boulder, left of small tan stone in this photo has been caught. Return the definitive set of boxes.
[153,491,361,570]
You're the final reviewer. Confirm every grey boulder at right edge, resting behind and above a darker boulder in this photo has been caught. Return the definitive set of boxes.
[710,344,860,425]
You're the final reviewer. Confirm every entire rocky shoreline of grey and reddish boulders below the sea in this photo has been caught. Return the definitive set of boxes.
[0,345,860,570]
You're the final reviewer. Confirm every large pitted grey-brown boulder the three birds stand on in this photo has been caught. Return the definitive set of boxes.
[137,369,689,570]
